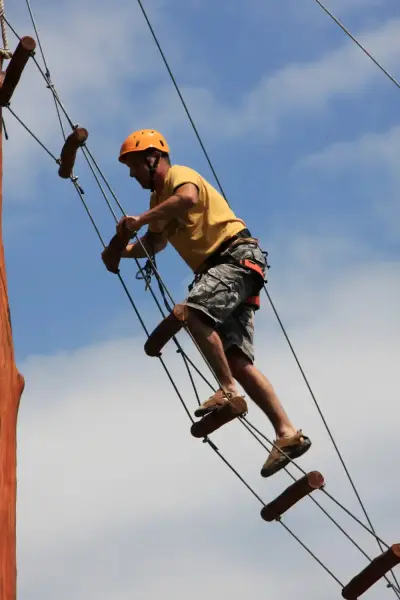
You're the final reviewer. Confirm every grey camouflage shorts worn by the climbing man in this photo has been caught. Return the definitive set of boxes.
[186,243,267,362]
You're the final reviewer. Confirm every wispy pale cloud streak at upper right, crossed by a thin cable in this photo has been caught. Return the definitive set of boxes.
[238,19,400,134]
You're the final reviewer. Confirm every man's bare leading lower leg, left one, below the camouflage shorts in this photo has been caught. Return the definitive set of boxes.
[187,307,238,396]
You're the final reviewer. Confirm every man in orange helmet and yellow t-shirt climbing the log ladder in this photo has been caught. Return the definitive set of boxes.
[102,130,311,477]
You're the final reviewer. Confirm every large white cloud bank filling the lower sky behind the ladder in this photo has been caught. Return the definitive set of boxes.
[14,231,400,600]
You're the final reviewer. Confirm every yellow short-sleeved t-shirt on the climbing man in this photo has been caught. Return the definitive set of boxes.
[149,165,246,271]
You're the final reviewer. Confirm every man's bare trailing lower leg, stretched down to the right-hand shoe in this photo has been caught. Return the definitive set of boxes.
[228,350,296,439]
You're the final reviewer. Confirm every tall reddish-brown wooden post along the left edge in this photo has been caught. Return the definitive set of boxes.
[0,36,34,600]
